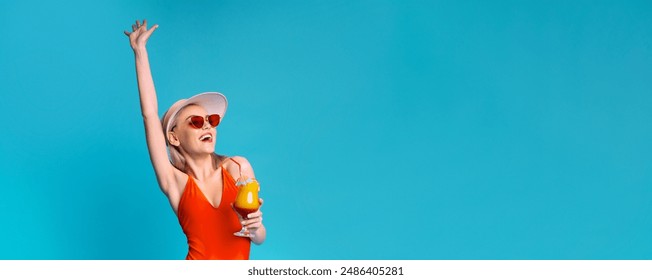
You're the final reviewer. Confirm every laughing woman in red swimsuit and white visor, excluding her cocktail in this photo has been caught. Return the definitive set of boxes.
[125,20,266,259]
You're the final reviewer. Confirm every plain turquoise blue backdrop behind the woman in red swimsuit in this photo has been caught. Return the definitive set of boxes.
[0,0,652,259]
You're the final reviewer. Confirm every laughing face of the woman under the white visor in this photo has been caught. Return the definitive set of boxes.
[172,105,217,155]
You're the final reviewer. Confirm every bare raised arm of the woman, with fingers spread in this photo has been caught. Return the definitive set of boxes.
[125,20,175,195]
